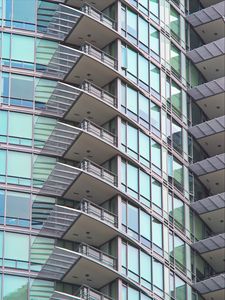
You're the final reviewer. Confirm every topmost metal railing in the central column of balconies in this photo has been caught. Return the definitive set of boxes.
[81,3,117,30]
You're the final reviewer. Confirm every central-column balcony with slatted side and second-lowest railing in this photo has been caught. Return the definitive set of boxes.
[38,244,119,289]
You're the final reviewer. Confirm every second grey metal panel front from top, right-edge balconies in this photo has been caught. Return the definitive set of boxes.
[187,38,225,64]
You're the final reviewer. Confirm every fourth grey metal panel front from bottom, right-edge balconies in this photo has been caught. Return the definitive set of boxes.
[190,153,225,176]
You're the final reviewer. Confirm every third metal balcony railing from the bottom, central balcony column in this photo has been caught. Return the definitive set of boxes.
[79,199,118,227]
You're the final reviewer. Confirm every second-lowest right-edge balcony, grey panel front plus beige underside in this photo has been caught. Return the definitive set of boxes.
[192,233,225,273]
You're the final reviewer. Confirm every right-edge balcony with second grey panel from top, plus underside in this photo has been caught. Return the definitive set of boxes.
[187,38,225,81]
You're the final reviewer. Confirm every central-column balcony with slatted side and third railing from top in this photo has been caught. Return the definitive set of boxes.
[36,81,119,124]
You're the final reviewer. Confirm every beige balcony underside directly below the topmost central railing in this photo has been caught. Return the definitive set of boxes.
[65,12,119,48]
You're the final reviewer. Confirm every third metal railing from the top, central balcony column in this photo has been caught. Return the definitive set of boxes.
[81,81,117,107]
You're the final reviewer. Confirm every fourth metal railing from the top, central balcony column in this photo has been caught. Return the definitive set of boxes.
[80,119,117,146]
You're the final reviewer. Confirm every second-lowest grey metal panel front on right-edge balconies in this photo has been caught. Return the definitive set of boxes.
[192,233,225,253]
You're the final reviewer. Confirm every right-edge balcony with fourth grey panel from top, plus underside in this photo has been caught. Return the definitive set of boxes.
[189,116,225,156]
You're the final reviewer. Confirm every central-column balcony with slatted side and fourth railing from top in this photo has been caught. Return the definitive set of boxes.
[39,118,119,164]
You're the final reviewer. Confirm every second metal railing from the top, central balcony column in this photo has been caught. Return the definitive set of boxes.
[81,42,118,70]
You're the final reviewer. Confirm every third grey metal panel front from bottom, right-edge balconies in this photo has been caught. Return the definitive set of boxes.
[191,193,225,214]
